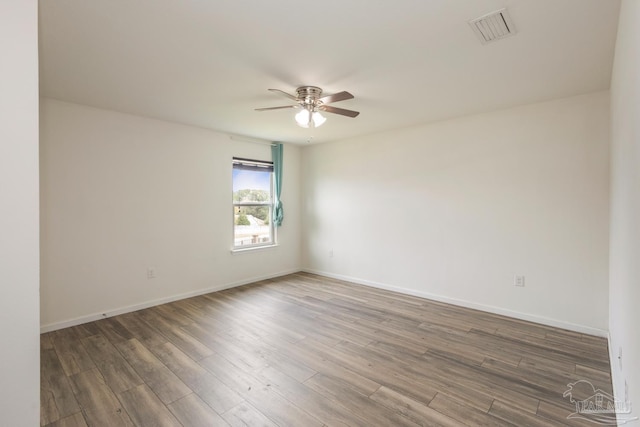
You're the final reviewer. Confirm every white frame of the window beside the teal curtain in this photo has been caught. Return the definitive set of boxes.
[231,157,277,252]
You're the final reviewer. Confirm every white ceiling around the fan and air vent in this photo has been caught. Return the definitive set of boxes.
[40,0,619,143]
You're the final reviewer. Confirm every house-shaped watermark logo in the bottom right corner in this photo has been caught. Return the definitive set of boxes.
[562,380,638,425]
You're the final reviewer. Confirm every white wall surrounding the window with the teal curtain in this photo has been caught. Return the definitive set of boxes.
[41,99,301,330]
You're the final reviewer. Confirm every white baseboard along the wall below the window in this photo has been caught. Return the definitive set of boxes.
[40,269,300,334]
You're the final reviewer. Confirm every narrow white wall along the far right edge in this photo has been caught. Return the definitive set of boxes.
[609,0,640,417]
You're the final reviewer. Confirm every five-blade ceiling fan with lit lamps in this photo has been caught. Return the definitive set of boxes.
[256,86,360,128]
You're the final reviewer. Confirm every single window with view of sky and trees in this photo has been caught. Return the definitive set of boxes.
[233,157,275,249]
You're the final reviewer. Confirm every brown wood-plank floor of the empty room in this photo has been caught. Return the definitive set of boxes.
[41,273,611,427]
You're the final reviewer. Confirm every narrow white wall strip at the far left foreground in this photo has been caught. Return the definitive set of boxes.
[0,0,40,427]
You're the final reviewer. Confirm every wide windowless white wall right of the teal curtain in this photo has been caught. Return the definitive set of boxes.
[302,92,609,335]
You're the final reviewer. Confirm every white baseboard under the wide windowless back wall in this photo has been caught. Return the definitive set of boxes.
[302,268,609,338]
